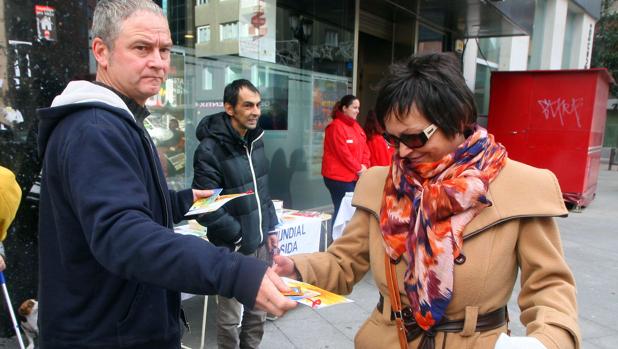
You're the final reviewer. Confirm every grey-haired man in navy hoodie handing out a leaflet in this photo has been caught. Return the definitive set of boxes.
[39,0,295,349]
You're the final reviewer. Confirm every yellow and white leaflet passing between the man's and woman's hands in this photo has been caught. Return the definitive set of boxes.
[281,277,353,309]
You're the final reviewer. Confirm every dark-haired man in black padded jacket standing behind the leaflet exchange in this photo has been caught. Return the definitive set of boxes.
[193,79,278,349]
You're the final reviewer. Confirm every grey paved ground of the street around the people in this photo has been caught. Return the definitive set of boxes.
[0,164,618,349]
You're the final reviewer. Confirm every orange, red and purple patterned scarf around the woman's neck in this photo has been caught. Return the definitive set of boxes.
[380,126,507,331]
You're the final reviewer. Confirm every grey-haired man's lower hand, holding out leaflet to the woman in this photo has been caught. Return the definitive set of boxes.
[255,268,296,316]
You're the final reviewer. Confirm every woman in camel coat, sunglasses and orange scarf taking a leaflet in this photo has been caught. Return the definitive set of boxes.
[275,53,581,349]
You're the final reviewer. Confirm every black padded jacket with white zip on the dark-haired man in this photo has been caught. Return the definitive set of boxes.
[193,112,277,254]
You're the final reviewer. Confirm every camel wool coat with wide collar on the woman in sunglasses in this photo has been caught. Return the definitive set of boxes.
[291,160,581,349]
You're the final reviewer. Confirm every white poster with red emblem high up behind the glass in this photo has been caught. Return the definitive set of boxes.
[238,0,277,63]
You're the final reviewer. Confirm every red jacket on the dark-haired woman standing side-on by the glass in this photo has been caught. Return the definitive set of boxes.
[322,113,369,182]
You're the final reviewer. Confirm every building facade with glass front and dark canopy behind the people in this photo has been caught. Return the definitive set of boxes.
[0,0,601,209]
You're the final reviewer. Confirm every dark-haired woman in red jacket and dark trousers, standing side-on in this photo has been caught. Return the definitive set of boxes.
[322,95,369,217]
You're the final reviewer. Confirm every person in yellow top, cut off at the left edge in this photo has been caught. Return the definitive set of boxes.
[0,166,21,272]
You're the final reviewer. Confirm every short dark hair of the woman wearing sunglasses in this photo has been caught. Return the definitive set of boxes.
[375,52,477,138]
